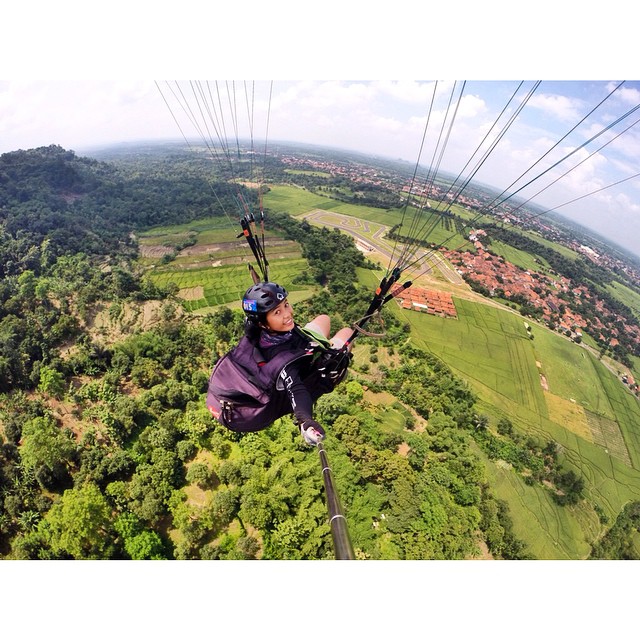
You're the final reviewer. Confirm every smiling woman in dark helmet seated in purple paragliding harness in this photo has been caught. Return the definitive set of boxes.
[207,282,352,445]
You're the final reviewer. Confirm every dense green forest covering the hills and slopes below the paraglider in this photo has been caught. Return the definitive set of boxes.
[0,146,640,560]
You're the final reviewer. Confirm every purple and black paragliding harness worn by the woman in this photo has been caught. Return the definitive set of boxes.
[207,327,351,432]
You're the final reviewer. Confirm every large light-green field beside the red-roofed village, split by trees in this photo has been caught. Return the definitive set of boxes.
[378,282,640,558]
